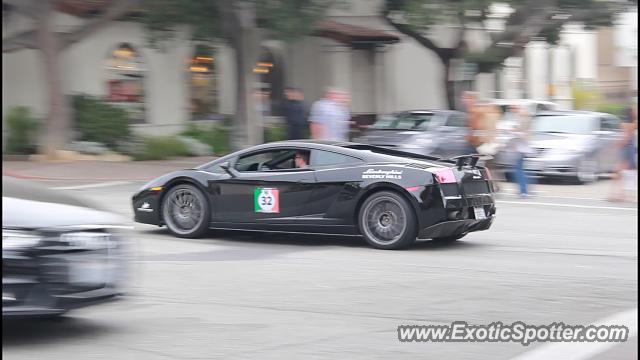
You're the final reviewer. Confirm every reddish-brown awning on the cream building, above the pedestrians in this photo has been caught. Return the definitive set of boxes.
[314,20,400,48]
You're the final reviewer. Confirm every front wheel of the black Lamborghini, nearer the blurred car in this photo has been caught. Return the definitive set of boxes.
[162,184,210,238]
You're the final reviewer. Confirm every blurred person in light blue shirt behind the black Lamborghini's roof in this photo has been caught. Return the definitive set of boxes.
[309,88,351,141]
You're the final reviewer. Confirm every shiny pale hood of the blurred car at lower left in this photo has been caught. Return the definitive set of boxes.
[2,177,125,229]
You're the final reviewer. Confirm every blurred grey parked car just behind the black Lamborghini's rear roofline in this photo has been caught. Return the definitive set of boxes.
[354,110,468,157]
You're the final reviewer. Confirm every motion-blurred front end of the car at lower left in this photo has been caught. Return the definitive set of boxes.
[2,177,128,318]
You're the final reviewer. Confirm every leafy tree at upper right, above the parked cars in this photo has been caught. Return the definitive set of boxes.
[382,0,635,108]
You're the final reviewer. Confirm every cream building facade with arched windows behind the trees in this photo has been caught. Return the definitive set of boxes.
[2,0,637,140]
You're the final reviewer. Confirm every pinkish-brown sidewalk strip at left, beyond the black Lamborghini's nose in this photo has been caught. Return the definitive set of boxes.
[2,156,215,181]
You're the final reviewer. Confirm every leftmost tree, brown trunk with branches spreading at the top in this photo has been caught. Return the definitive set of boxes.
[2,0,137,158]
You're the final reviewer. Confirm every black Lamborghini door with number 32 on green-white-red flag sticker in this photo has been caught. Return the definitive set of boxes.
[213,148,315,224]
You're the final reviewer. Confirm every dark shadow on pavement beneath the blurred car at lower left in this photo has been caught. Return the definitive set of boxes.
[2,316,117,349]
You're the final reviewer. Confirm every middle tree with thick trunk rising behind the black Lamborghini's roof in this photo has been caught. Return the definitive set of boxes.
[141,0,333,149]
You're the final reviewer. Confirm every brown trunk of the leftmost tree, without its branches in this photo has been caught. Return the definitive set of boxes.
[37,1,71,159]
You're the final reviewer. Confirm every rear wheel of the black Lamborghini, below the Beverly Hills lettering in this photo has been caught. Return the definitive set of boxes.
[358,191,418,250]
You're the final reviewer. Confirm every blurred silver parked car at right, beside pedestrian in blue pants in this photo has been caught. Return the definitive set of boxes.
[496,111,622,183]
